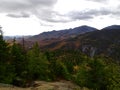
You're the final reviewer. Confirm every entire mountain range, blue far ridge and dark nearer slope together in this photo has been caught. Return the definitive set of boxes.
[16,25,120,60]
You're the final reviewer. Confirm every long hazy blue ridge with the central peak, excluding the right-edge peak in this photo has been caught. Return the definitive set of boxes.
[30,25,97,41]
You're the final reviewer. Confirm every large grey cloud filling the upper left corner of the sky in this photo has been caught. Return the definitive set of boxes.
[0,0,57,21]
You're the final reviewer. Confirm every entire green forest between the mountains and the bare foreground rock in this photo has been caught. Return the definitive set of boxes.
[0,29,120,90]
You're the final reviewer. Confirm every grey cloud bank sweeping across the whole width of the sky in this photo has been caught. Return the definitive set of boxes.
[0,0,120,23]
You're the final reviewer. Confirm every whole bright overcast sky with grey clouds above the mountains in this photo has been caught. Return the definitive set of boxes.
[0,0,120,36]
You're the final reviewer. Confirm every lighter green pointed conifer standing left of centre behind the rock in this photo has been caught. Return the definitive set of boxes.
[27,43,49,80]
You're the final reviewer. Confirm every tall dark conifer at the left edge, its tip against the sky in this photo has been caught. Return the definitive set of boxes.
[0,27,15,83]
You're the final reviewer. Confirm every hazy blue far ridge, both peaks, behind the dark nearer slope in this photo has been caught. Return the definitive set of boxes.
[28,25,120,41]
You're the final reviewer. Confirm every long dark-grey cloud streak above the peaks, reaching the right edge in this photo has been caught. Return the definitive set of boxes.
[67,8,120,21]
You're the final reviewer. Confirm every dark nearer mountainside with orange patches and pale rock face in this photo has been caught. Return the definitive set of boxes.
[44,25,120,60]
